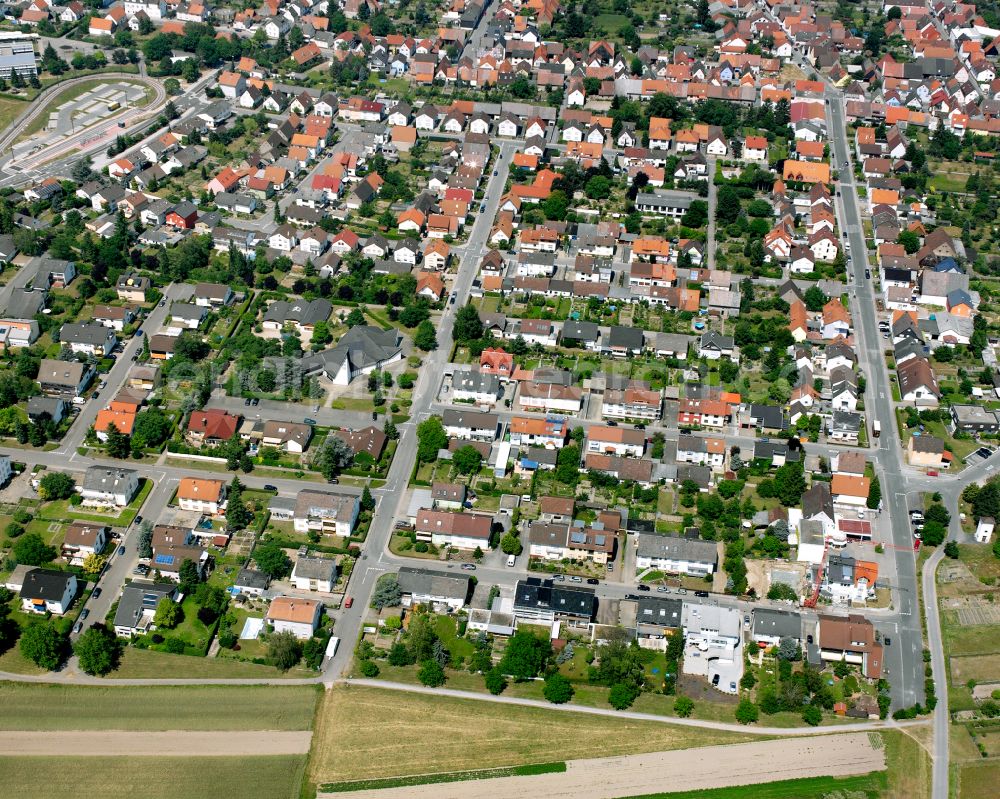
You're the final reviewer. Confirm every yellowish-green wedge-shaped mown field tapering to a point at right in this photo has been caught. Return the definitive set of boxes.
[309,686,747,784]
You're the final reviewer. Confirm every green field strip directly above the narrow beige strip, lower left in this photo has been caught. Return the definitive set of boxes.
[0,683,317,731]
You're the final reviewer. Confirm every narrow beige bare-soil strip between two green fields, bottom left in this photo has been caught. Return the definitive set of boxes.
[0,730,312,757]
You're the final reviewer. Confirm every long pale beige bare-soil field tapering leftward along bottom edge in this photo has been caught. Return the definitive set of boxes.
[319,733,886,799]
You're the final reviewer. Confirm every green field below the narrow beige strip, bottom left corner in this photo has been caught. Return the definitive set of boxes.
[0,755,305,799]
